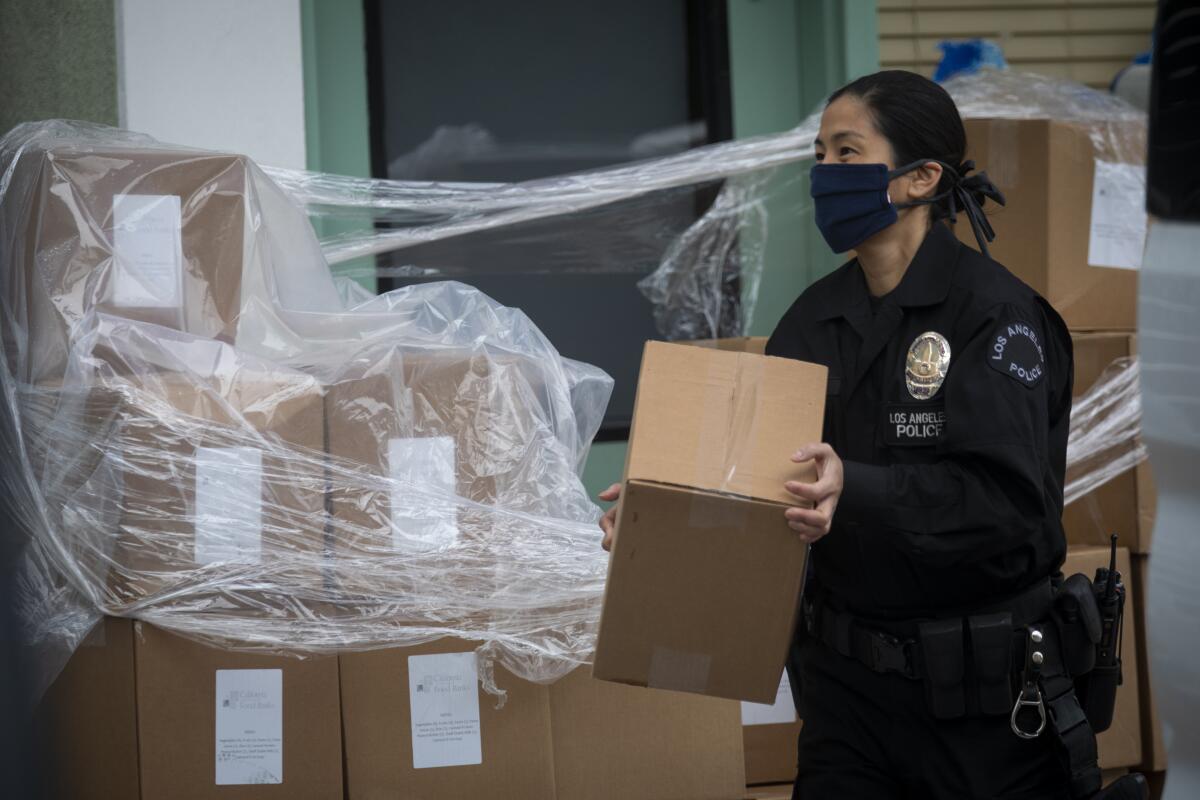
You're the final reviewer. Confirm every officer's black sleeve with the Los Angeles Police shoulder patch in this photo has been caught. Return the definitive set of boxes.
[836,305,1072,555]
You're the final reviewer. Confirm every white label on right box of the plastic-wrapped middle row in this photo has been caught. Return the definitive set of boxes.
[388,437,458,551]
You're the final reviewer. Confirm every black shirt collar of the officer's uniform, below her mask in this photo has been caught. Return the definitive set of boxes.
[816,222,960,319]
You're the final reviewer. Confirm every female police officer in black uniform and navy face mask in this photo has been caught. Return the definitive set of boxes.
[767,71,1094,799]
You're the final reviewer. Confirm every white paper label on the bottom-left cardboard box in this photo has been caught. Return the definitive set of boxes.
[216,669,283,786]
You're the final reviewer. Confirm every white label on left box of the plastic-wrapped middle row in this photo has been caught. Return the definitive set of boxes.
[196,447,263,565]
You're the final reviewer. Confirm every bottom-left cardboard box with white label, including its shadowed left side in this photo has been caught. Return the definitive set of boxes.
[38,618,342,800]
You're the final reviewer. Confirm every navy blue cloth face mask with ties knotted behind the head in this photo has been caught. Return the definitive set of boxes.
[811,158,1004,254]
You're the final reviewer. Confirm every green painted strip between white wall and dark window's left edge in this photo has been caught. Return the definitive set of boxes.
[300,0,376,291]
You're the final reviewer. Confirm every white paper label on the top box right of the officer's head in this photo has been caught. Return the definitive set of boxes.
[1087,160,1146,270]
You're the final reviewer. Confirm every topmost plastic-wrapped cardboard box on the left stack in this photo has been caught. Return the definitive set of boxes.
[2,144,253,381]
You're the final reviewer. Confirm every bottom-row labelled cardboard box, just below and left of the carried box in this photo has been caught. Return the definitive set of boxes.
[341,639,745,800]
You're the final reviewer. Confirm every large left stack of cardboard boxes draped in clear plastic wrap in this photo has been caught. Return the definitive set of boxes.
[0,124,748,800]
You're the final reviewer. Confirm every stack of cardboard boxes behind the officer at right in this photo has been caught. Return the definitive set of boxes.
[959,115,1166,786]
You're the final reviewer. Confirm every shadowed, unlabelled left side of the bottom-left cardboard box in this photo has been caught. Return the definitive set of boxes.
[36,616,140,800]
